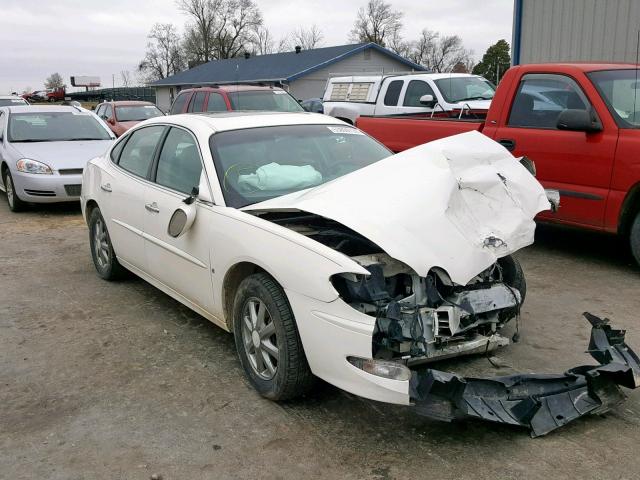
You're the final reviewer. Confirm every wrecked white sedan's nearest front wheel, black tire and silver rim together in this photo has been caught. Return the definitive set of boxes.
[233,273,314,400]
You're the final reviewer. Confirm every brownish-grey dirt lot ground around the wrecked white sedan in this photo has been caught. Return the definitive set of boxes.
[0,199,640,480]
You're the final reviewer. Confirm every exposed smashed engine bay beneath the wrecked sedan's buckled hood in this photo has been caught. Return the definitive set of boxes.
[252,212,526,363]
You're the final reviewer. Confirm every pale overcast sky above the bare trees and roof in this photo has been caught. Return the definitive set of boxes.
[0,0,513,94]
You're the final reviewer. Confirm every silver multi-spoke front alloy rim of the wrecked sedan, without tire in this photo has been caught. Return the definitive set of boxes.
[242,297,280,380]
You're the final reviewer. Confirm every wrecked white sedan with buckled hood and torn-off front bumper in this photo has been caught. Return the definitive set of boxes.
[81,112,635,434]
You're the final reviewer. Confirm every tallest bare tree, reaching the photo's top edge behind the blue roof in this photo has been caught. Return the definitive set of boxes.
[177,0,263,63]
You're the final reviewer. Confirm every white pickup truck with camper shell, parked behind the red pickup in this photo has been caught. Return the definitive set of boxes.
[322,73,496,124]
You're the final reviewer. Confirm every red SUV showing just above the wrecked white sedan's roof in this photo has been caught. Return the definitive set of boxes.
[170,85,304,115]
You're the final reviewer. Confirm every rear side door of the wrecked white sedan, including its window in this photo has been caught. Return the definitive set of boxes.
[99,125,165,271]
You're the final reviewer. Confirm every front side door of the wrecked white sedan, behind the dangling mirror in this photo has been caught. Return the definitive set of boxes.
[145,126,213,310]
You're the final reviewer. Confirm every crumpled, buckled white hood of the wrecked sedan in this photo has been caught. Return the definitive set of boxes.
[243,131,550,285]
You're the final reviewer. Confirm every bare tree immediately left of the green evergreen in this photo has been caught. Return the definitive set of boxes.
[409,28,472,72]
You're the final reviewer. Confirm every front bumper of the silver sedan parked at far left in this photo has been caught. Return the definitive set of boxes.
[11,171,82,203]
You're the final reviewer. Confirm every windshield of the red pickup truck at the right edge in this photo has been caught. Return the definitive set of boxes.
[587,69,640,128]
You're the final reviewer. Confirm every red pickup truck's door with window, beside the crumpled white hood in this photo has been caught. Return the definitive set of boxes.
[494,74,617,227]
